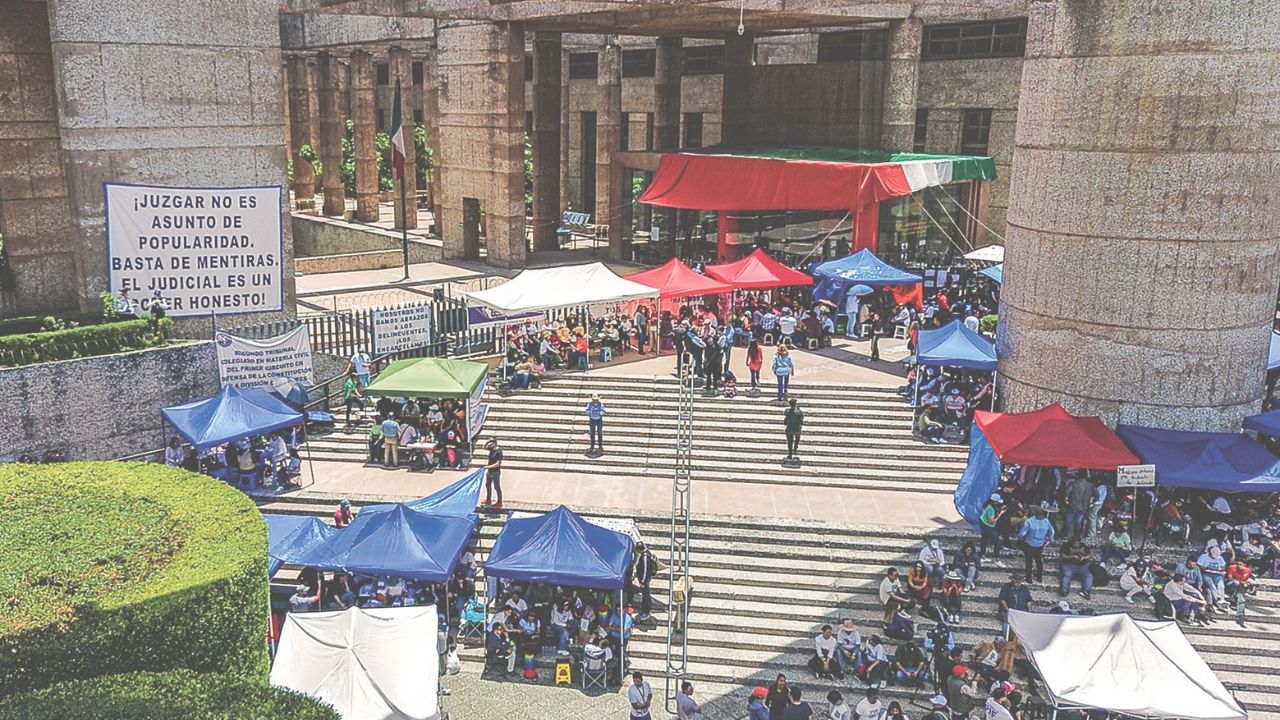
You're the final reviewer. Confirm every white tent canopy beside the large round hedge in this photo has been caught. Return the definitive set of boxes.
[271,606,440,720]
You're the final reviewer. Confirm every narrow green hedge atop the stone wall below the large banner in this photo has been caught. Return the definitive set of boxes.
[0,318,173,366]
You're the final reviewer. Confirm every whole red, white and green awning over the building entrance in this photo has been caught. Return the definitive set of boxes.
[640,147,996,211]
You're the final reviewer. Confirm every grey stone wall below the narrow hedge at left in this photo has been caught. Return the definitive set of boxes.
[0,342,347,461]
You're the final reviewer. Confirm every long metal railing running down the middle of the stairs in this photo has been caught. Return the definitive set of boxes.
[666,354,695,714]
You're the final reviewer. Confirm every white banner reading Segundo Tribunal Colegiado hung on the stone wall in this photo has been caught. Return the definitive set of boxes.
[214,325,315,387]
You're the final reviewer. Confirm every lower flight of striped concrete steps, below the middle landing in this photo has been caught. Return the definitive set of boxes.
[262,497,1280,720]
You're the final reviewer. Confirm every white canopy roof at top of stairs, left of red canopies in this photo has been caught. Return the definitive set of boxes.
[467,263,658,314]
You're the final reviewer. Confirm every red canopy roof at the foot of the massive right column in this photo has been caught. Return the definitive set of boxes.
[973,402,1139,470]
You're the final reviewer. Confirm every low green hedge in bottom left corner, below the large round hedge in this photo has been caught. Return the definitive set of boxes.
[0,670,340,720]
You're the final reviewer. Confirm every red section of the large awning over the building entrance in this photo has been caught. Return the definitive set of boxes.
[640,152,911,210]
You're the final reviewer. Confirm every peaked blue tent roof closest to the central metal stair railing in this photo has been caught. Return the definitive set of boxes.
[484,505,632,589]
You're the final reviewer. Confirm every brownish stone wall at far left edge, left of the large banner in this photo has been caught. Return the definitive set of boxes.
[0,0,79,315]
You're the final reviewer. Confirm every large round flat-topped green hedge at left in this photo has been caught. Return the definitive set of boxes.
[0,462,269,697]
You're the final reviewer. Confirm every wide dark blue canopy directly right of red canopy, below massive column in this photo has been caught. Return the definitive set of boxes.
[1116,425,1280,492]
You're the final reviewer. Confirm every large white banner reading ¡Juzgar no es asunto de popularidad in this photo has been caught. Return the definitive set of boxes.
[105,183,284,318]
